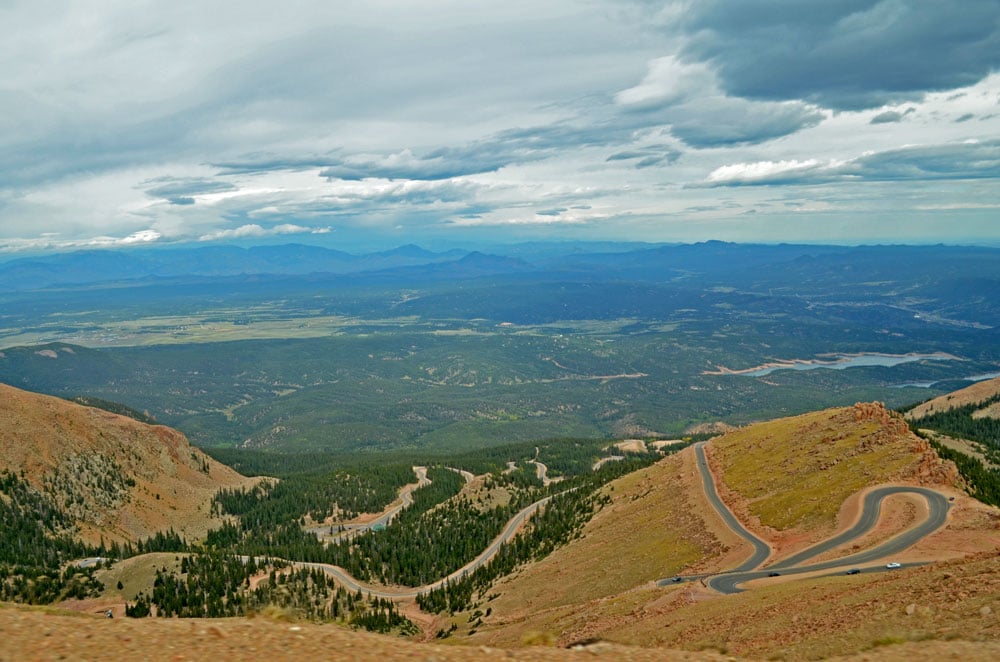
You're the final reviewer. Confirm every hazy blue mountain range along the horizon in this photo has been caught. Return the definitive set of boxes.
[7,241,1000,292]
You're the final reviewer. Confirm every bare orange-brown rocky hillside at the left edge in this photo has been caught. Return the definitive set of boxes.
[0,384,253,542]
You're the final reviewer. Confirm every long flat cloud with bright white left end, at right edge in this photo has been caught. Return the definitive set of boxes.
[698,140,1000,188]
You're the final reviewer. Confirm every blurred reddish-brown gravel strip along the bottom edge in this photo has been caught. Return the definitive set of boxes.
[0,606,730,662]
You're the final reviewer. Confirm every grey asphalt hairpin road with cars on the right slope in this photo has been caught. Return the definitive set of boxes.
[676,442,949,594]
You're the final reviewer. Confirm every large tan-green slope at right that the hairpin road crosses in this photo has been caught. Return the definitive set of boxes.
[470,403,1000,659]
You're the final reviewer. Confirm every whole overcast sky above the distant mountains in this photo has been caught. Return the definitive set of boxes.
[0,0,1000,254]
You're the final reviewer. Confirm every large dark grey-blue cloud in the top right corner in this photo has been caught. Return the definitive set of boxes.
[664,0,1000,110]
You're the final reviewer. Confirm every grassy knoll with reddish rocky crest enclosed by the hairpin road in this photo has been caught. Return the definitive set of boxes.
[709,403,958,542]
